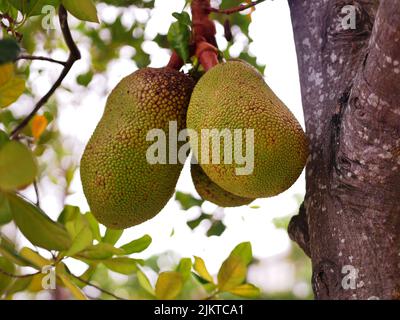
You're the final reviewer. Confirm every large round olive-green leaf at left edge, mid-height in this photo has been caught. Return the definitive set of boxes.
[0,141,38,190]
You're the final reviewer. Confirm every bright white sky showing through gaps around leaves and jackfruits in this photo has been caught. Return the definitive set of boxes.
[7,0,305,296]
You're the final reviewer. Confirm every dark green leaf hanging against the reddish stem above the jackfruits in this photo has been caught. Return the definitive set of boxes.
[167,21,191,62]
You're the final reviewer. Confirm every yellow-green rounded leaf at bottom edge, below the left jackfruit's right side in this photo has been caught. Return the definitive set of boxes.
[156,271,183,300]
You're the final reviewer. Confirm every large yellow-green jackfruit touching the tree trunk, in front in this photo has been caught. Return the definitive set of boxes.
[187,60,308,198]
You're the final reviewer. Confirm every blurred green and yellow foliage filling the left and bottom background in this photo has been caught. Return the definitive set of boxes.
[0,0,312,299]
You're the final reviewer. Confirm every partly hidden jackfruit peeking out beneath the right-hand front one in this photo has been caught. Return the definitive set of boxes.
[190,163,255,208]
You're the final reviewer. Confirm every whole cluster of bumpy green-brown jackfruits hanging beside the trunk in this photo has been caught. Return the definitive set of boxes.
[81,61,308,229]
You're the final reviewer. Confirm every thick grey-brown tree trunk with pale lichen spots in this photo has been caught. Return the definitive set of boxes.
[289,0,400,299]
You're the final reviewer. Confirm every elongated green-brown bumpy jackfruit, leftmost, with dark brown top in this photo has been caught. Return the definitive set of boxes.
[81,68,194,229]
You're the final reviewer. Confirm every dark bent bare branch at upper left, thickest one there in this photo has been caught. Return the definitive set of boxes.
[11,5,81,139]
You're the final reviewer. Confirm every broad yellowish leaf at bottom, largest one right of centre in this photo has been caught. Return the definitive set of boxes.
[218,255,247,291]
